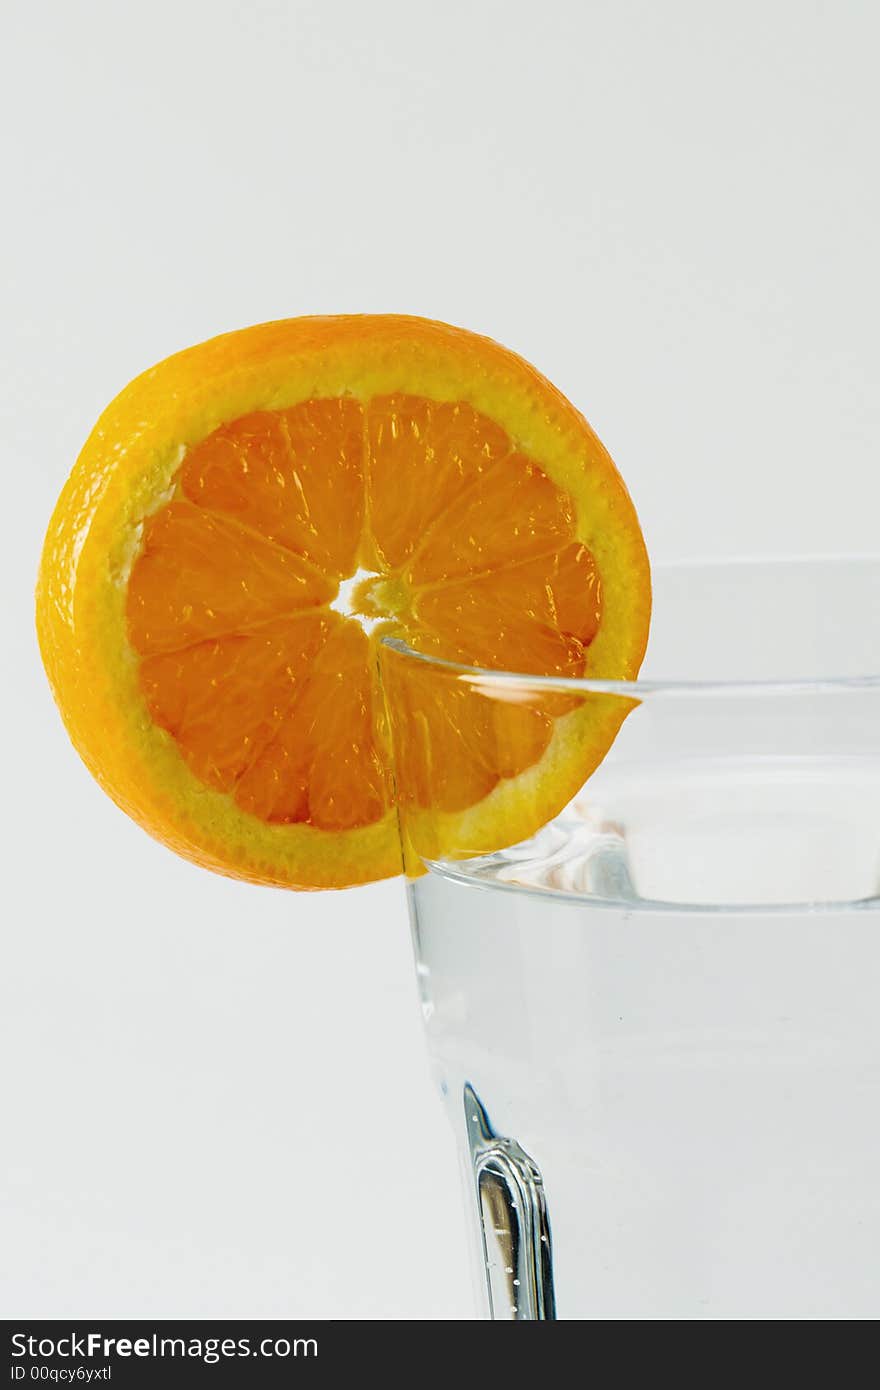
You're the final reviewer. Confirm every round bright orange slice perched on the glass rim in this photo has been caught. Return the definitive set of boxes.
[38,316,651,888]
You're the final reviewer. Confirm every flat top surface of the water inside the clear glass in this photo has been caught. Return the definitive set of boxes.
[434,756,880,910]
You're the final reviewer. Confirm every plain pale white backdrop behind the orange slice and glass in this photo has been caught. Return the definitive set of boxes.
[0,0,880,1319]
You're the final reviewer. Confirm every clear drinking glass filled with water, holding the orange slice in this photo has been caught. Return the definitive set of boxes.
[382,557,880,1321]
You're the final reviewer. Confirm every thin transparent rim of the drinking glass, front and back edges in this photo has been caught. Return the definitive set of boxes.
[380,552,880,699]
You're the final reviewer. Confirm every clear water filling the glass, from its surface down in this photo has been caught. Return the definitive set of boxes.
[409,758,880,1319]
